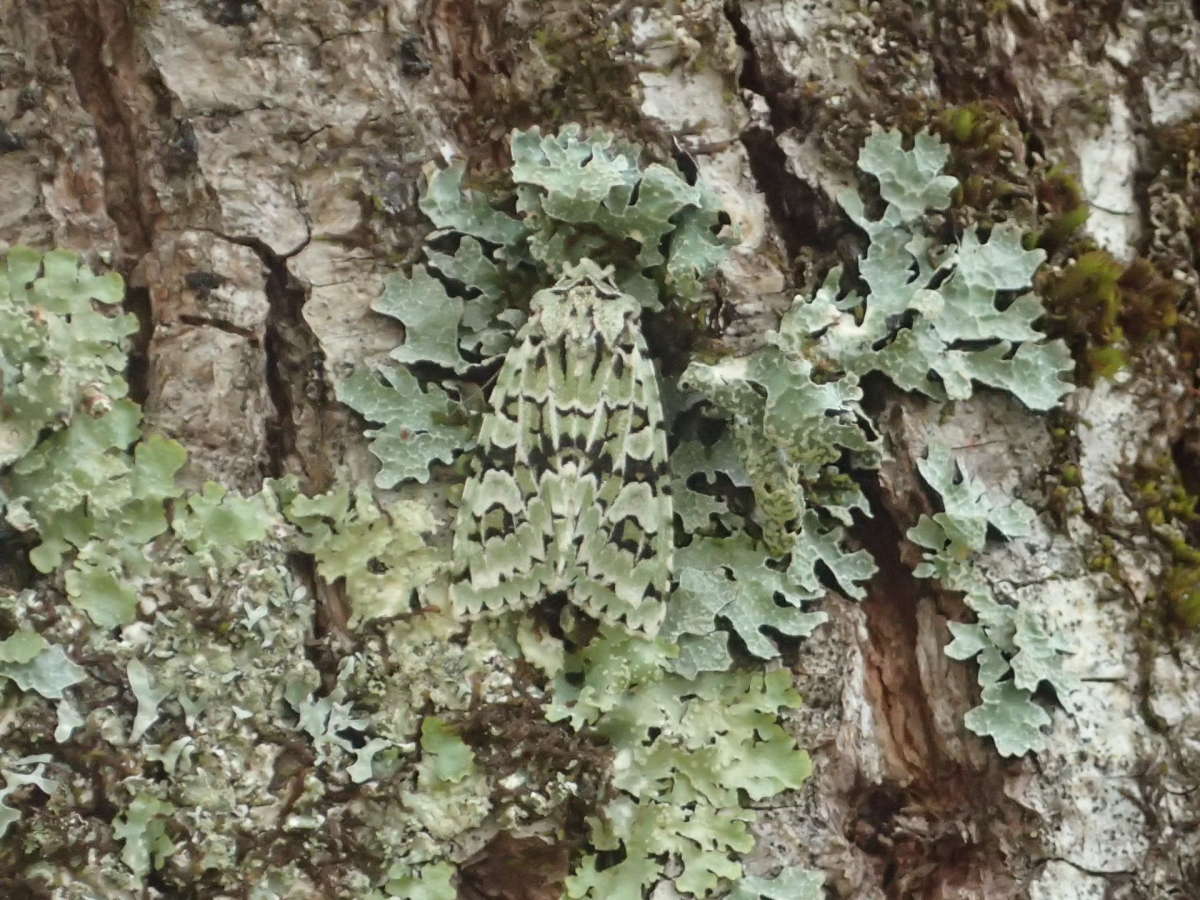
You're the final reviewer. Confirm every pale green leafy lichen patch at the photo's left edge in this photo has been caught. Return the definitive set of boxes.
[0,247,184,625]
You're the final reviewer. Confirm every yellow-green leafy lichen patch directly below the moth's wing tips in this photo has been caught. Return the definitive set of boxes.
[548,631,809,899]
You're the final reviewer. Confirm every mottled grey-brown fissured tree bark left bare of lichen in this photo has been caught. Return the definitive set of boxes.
[0,0,1200,900]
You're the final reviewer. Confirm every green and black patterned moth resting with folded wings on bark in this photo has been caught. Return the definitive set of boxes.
[450,259,674,635]
